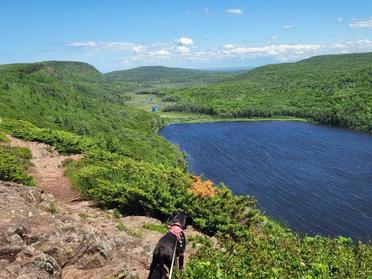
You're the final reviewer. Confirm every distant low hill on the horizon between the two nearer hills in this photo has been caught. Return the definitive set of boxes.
[105,66,234,84]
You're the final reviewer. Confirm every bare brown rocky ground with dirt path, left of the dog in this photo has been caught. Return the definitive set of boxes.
[0,139,205,279]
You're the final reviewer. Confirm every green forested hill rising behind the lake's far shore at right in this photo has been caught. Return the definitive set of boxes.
[166,53,372,131]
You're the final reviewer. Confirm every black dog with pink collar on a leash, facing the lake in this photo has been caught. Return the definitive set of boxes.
[148,213,187,279]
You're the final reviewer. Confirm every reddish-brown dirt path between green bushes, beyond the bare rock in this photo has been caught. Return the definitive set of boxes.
[10,137,82,203]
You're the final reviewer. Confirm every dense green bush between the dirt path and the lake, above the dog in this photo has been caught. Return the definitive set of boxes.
[68,155,257,239]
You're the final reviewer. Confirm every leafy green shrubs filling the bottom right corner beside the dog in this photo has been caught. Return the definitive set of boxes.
[182,223,372,279]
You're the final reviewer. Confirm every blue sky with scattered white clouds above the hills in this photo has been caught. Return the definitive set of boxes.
[0,0,372,72]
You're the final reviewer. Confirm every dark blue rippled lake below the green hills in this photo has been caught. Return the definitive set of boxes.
[160,121,372,241]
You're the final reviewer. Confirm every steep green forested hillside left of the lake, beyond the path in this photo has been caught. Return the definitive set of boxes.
[0,61,183,165]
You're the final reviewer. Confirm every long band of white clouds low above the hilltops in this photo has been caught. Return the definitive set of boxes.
[67,35,372,65]
